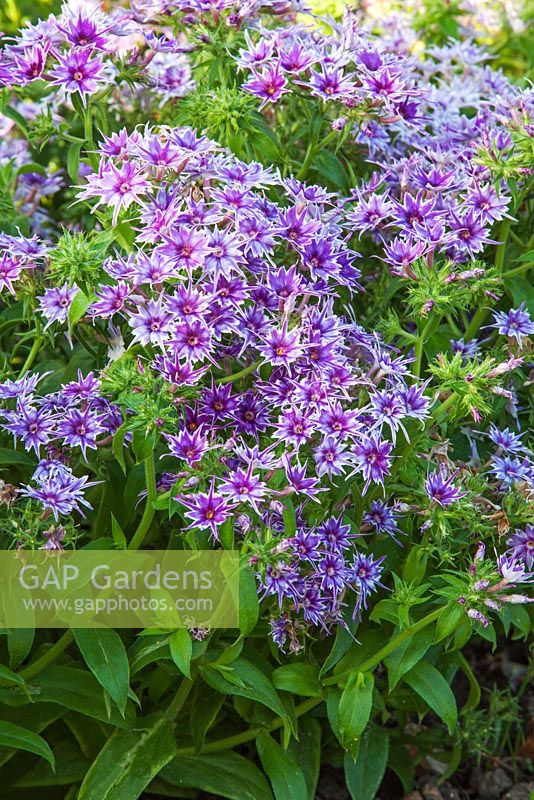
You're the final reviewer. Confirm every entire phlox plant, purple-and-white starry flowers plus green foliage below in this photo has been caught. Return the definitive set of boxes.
[0,0,534,800]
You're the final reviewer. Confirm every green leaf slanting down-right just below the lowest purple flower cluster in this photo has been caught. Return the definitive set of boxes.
[200,658,287,717]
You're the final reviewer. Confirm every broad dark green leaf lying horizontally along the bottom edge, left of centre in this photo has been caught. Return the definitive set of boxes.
[160,750,273,800]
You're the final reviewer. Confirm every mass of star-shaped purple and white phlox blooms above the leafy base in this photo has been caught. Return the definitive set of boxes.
[0,0,534,651]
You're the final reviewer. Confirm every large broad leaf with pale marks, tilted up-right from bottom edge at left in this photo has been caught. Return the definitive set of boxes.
[78,714,176,800]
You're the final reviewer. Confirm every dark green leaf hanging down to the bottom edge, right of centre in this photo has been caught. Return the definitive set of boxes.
[344,725,389,800]
